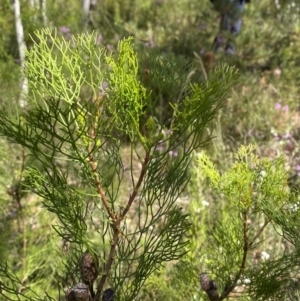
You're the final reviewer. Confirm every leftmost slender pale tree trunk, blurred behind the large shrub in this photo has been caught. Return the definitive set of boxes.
[13,0,28,108]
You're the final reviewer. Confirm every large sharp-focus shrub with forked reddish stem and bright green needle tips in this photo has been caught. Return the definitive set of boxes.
[0,30,237,301]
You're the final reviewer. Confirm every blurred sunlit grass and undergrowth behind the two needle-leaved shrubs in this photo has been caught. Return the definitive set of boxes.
[0,0,300,300]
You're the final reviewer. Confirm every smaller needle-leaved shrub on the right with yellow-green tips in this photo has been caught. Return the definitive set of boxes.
[198,145,300,301]
